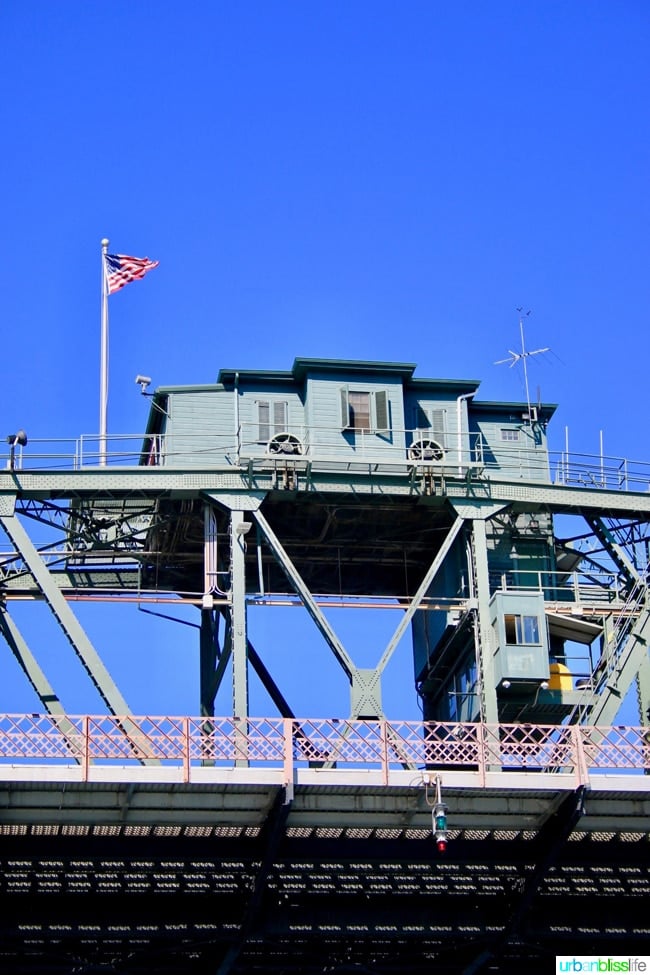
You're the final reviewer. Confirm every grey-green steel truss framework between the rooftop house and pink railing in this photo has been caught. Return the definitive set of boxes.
[0,465,650,724]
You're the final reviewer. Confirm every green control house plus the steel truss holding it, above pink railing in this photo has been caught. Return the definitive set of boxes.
[0,358,636,724]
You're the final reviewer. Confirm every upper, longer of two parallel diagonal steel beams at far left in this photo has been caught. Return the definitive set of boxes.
[0,515,130,715]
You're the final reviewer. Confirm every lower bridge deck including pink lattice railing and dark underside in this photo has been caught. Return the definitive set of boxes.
[0,715,650,973]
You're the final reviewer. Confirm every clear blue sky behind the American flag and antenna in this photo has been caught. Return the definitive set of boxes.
[0,0,650,712]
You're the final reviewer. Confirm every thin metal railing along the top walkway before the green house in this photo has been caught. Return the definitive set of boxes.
[0,432,650,492]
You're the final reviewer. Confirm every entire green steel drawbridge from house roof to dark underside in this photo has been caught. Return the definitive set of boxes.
[0,359,650,975]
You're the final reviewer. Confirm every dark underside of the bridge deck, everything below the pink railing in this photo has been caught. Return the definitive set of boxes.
[0,769,650,975]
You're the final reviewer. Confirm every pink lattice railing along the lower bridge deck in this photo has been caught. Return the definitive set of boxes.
[0,714,650,782]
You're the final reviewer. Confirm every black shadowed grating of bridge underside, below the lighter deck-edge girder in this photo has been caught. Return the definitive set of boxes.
[0,827,650,975]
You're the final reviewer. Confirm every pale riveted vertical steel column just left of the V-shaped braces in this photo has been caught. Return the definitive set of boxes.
[230,510,251,718]
